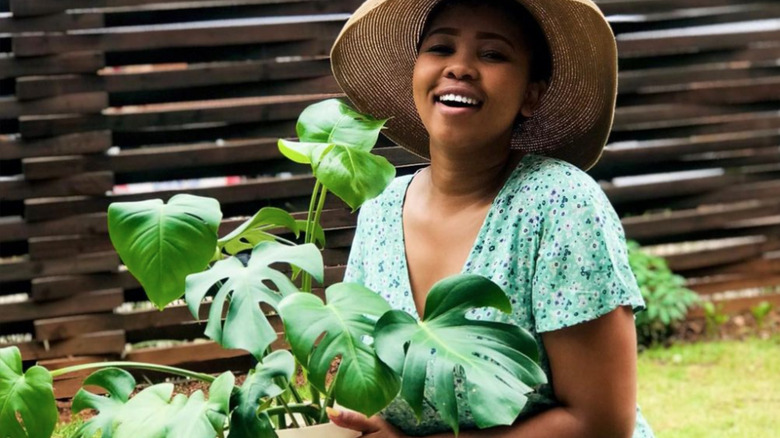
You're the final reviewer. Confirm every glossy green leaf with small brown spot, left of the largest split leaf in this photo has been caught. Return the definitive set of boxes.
[279,283,399,415]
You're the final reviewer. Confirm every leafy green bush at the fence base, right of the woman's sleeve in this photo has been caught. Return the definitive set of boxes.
[628,242,699,345]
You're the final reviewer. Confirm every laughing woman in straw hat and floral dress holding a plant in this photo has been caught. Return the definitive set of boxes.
[322,0,652,438]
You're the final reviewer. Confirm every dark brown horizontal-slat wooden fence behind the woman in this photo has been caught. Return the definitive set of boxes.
[0,0,780,396]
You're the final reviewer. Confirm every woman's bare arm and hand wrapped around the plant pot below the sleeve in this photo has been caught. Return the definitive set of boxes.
[331,307,636,438]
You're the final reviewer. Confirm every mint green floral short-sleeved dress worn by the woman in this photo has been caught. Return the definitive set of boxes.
[344,155,653,438]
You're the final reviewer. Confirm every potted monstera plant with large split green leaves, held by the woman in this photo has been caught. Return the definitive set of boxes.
[0,100,545,438]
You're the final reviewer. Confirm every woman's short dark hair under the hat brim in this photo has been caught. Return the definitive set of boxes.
[417,0,552,82]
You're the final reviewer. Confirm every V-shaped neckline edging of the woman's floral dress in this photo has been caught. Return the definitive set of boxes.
[394,159,530,321]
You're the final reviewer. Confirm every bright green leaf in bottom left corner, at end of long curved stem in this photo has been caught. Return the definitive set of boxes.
[0,347,57,438]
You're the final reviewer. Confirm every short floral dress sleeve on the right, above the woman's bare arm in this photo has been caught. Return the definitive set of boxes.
[532,177,644,332]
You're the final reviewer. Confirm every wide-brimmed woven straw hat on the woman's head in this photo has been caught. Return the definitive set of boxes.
[331,0,617,170]
